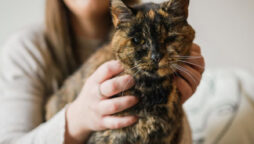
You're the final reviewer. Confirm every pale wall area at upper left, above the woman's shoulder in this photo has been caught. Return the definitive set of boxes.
[0,0,44,46]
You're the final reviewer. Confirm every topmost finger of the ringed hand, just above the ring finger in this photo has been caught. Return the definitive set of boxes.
[90,60,123,83]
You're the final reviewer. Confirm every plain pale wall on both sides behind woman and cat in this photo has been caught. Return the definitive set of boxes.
[0,0,254,73]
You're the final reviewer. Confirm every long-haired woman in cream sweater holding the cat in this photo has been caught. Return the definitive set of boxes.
[0,0,204,144]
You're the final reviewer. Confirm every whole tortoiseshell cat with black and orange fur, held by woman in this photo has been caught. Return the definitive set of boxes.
[46,0,195,144]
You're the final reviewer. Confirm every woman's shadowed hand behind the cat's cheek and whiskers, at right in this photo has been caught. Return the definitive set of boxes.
[176,44,205,103]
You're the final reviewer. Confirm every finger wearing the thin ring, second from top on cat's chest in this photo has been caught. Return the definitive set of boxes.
[100,75,135,97]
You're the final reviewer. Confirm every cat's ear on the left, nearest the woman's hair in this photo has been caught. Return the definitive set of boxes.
[111,0,133,27]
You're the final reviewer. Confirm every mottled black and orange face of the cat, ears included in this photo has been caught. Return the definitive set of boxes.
[112,0,195,76]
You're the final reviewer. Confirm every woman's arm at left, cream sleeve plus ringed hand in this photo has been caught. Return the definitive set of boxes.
[0,27,137,144]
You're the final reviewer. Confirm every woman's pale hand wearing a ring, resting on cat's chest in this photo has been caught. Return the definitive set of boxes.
[66,61,138,144]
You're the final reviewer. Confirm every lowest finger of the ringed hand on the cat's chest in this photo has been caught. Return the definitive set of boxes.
[102,116,138,129]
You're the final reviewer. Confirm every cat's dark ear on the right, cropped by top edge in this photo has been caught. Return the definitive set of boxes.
[161,0,189,18]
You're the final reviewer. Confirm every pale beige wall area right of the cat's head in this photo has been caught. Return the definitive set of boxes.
[190,0,254,72]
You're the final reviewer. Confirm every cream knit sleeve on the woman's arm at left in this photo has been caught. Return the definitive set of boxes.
[0,25,68,144]
